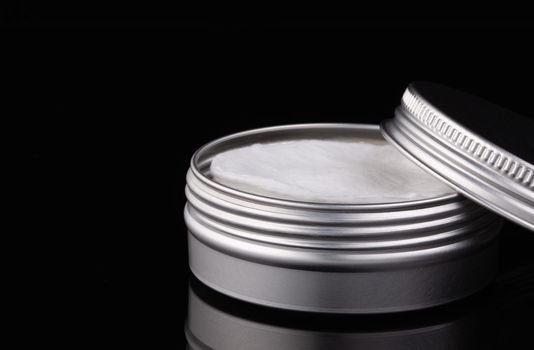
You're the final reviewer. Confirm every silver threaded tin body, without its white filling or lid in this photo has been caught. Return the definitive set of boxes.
[185,124,501,313]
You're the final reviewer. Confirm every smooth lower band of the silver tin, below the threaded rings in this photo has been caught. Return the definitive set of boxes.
[189,234,498,314]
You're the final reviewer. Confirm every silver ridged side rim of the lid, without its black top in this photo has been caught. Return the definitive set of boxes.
[381,81,534,230]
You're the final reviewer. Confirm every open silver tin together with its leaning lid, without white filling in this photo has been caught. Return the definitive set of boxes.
[185,83,534,313]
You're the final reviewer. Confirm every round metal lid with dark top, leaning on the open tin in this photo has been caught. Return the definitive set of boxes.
[381,82,534,230]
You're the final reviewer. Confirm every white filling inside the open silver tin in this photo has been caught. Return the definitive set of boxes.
[210,140,454,204]
